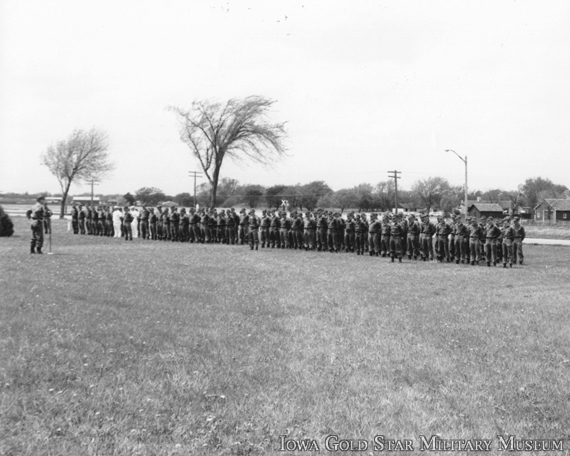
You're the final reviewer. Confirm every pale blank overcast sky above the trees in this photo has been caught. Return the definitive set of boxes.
[0,0,570,194]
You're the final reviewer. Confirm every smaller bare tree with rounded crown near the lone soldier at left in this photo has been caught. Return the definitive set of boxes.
[41,128,114,218]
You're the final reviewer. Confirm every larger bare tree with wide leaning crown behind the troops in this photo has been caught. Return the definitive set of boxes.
[169,96,287,207]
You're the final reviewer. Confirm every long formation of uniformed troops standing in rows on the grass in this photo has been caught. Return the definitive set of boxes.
[72,206,525,267]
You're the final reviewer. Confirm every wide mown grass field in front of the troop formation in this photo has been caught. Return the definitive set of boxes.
[0,217,570,456]
